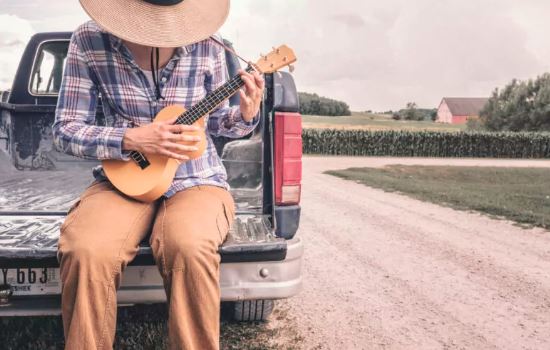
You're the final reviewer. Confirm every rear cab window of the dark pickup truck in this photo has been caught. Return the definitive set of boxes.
[30,41,69,95]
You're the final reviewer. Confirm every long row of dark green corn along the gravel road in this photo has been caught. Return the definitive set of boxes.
[302,129,550,159]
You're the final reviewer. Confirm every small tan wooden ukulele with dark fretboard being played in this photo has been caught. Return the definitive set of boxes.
[101,45,296,203]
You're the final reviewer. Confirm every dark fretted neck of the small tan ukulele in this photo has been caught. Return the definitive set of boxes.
[176,66,254,125]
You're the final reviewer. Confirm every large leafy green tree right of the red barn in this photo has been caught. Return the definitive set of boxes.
[480,73,550,131]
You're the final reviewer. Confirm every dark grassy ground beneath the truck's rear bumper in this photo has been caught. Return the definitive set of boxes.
[0,304,303,350]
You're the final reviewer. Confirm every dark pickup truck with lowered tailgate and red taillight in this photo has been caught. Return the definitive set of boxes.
[0,32,303,321]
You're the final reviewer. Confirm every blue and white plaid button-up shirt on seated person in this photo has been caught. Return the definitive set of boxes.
[53,21,260,197]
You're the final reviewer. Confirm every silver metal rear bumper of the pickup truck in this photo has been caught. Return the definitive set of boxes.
[0,238,304,316]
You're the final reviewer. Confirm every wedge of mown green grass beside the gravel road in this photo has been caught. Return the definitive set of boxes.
[326,165,550,229]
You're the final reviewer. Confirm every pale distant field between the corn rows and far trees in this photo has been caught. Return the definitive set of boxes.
[302,112,466,132]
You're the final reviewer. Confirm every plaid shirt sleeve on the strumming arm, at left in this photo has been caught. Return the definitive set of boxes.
[52,31,129,160]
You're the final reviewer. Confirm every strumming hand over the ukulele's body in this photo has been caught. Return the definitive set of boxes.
[122,117,201,161]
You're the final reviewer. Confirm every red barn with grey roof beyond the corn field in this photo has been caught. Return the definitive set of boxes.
[437,97,489,124]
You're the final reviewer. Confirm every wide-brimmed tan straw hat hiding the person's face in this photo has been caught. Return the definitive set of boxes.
[80,0,229,47]
